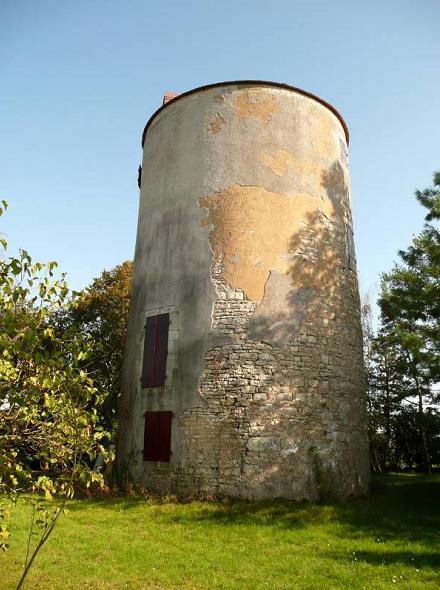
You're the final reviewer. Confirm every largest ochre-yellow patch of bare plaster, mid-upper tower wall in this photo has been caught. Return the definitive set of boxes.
[199,184,333,301]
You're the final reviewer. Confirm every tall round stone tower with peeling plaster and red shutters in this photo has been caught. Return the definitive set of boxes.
[117,81,369,499]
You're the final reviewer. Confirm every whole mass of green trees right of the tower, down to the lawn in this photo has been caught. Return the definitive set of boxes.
[364,173,440,472]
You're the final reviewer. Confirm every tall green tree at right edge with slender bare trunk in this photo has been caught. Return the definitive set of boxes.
[379,172,440,472]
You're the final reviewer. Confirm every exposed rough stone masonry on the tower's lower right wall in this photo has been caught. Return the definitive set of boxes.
[174,208,365,498]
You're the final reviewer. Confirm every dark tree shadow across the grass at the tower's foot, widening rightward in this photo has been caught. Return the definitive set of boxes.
[61,474,440,571]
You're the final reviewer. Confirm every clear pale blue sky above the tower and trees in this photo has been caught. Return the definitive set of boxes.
[0,0,440,314]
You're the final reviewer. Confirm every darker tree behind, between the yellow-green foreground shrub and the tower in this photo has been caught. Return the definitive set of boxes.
[56,260,132,434]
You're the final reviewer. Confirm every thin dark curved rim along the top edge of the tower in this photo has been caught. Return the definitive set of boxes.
[141,80,350,147]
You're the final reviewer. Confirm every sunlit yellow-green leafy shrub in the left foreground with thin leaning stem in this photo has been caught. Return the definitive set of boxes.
[0,202,107,588]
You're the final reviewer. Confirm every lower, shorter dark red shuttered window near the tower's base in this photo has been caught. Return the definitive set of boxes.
[144,412,173,463]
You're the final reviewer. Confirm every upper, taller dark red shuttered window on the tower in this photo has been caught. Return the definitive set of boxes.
[141,313,170,387]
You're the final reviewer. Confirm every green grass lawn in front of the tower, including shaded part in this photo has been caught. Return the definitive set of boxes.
[0,475,440,590]
